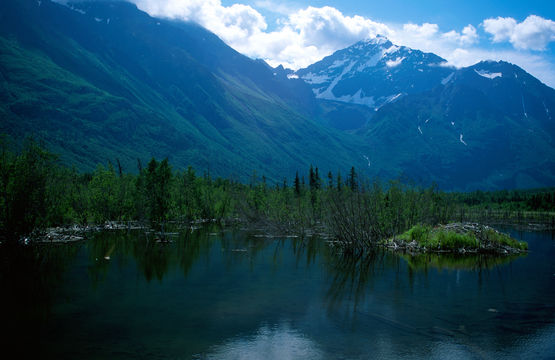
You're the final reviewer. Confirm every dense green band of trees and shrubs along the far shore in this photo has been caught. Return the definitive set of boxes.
[0,139,555,246]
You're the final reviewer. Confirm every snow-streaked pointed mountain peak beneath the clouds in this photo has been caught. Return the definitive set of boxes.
[296,36,454,110]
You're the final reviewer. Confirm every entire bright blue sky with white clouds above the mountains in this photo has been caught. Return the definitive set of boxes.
[130,0,555,87]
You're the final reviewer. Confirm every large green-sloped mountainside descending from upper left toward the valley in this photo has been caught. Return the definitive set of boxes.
[0,0,363,180]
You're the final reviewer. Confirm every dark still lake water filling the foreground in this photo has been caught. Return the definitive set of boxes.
[2,229,555,360]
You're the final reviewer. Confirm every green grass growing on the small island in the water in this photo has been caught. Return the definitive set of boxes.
[397,225,528,251]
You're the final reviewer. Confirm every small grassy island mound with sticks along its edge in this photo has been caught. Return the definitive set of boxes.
[383,223,528,255]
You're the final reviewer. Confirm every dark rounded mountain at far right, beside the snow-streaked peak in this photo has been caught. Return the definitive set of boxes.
[361,61,555,189]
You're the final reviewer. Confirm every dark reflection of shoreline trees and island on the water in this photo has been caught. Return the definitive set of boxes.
[87,226,519,290]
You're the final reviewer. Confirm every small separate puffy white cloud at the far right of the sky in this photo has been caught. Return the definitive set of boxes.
[482,15,555,51]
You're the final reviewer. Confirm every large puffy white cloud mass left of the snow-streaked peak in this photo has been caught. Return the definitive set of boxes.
[131,0,392,69]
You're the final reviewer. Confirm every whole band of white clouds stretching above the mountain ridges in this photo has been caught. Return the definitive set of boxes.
[130,0,555,86]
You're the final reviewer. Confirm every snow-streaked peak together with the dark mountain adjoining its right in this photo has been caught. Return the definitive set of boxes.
[295,36,555,190]
